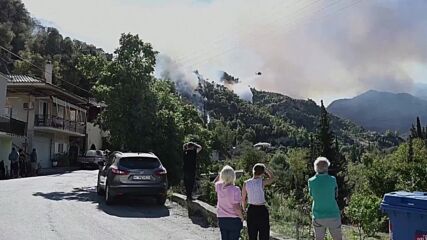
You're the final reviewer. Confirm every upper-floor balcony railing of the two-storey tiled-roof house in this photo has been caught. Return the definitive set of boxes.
[34,115,85,134]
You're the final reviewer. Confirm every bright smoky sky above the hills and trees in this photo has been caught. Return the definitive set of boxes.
[23,0,427,104]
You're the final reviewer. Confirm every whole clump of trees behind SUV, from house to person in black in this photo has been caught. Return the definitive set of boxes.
[78,34,211,184]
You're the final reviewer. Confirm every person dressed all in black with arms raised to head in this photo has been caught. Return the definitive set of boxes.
[182,142,202,201]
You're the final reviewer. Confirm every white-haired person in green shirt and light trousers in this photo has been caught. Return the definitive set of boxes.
[308,157,342,240]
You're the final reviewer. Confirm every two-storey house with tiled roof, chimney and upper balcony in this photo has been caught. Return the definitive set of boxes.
[0,70,88,168]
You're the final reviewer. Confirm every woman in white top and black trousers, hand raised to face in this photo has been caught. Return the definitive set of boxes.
[242,163,274,240]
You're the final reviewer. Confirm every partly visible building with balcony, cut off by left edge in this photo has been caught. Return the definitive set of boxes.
[0,75,26,172]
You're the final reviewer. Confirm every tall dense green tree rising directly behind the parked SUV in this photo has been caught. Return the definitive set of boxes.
[95,34,158,151]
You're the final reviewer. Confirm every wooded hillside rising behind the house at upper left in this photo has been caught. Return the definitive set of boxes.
[0,0,108,96]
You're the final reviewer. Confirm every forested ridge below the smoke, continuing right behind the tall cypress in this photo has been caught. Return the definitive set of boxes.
[199,82,402,149]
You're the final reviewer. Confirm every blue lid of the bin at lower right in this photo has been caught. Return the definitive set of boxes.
[382,192,427,210]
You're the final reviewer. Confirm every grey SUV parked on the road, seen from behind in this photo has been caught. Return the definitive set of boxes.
[96,152,168,205]
